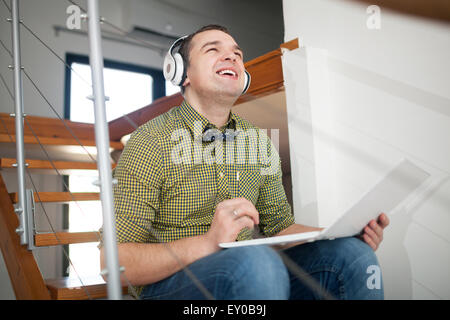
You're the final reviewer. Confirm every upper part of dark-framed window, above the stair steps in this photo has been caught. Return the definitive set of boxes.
[65,54,165,123]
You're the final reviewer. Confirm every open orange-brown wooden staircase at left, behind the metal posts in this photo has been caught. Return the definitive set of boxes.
[0,113,127,300]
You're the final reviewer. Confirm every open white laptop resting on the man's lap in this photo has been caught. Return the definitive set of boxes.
[219,159,430,248]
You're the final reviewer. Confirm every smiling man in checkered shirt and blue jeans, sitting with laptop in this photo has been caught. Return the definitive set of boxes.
[101,25,389,299]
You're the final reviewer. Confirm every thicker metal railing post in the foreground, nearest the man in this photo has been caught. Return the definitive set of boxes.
[88,0,122,300]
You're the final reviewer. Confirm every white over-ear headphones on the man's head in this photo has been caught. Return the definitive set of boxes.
[163,36,251,94]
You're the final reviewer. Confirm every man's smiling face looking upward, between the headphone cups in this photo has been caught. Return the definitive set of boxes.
[185,30,245,97]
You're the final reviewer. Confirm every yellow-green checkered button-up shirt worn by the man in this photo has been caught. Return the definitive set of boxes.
[114,101,294,292]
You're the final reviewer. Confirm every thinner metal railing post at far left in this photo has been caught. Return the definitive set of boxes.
[11,0,30,245]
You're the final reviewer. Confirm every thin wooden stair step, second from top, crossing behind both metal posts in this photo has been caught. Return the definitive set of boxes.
[0,133,123,150]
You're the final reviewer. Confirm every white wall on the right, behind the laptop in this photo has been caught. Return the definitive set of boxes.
[283,0,450,299]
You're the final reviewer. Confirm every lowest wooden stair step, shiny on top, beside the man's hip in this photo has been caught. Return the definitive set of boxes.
[45,276,128,300]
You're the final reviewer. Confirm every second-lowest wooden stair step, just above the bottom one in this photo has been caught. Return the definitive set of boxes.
[34,231,100,247]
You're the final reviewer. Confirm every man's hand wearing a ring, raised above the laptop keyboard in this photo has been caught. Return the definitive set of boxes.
[205,198,259,246]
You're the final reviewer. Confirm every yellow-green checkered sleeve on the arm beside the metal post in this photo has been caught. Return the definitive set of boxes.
[113,129,163,243]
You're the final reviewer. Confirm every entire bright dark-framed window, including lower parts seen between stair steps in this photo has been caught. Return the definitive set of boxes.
[63,54,166,278]
